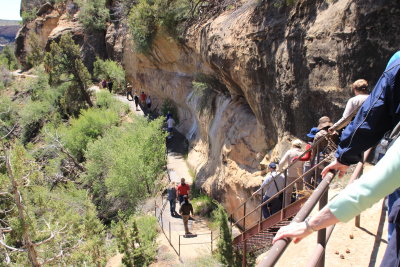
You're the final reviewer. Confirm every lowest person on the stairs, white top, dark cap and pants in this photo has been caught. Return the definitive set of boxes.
[253,162,285,219]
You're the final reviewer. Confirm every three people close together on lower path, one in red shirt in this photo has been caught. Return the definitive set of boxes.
[167,178,193,238]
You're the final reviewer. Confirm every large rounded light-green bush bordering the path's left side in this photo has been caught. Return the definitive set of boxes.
[83,117,166,217]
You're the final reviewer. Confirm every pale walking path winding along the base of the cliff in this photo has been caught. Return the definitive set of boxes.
[89,86,215,267]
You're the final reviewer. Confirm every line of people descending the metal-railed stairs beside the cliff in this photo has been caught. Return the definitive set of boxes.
[253,79,369,222]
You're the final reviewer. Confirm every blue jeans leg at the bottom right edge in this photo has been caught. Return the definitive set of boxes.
[381,199,400,267]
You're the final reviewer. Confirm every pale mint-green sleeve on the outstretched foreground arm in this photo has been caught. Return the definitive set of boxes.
[328,138,400,222]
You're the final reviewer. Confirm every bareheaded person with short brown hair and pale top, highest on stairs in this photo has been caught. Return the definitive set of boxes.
[328,79,369,133]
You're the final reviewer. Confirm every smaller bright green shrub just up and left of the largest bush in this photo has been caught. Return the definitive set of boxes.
[59,109,119,161]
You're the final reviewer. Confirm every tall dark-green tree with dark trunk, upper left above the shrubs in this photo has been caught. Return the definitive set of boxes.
[44,33,93,115]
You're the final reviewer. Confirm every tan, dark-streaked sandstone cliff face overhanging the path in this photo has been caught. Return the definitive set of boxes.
[17,0,400,220]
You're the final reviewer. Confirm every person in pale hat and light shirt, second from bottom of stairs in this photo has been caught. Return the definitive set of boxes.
[279,140,303,207]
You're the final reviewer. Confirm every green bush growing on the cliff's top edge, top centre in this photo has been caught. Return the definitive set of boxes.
[128,0,203,53]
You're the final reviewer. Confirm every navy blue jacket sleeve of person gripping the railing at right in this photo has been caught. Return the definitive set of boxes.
[336,56,400,165]
